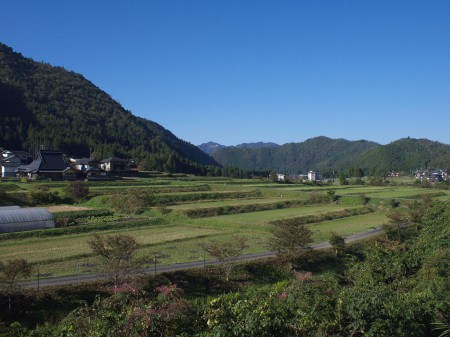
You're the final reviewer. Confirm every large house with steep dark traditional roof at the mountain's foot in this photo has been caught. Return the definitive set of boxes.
[18,150,75,180]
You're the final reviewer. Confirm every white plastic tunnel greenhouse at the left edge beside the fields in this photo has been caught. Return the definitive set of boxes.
[0,206,55,233]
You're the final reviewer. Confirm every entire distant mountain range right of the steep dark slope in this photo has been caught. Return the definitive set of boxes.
[207,136,450,176]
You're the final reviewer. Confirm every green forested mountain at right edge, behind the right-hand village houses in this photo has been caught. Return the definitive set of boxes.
[355,138,450,171]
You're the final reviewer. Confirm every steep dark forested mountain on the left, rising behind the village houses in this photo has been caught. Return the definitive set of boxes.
[0,43,218,172]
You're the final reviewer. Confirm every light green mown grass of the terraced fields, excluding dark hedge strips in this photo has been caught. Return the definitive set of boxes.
[0,177,450,276]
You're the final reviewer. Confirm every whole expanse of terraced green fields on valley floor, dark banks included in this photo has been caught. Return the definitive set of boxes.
[0,177,449,276]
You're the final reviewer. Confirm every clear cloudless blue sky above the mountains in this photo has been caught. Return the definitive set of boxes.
[0,0,450,145]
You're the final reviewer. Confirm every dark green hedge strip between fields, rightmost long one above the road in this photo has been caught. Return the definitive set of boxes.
[269,207,374,226]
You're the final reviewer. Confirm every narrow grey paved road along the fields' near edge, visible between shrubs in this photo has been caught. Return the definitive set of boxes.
[23,224,382,288]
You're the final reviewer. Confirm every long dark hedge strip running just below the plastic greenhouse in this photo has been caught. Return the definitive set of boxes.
[0,218,166,241]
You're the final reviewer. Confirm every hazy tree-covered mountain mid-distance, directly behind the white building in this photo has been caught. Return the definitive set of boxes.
[212,137,380,174]
